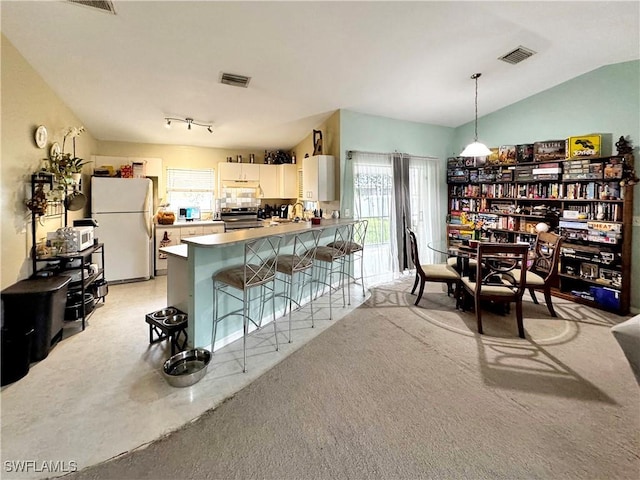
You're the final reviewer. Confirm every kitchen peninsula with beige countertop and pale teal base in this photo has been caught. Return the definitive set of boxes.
[163,219,356,350]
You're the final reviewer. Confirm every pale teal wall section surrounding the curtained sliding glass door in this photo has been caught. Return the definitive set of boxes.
[340,110,454,227]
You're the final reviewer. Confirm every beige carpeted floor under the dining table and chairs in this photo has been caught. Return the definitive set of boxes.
[67,279,640,479]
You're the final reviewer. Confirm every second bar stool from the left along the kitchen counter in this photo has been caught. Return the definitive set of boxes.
[277,229,320,343]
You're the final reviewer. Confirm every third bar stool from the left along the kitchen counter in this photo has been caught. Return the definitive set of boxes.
[314,224,353,320]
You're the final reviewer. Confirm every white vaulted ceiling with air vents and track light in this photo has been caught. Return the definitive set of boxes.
[0,0,640,150]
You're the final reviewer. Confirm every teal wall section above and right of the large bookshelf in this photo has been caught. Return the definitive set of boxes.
[453,60,640,313]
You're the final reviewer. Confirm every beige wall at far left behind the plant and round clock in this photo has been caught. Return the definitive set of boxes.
[0,35,96,288]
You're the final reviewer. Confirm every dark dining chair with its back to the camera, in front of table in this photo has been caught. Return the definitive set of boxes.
[461,243,529,338]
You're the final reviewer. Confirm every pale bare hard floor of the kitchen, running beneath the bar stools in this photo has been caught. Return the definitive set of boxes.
[0,277,380,478]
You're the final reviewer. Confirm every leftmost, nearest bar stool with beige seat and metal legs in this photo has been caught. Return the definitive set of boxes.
[211,235,282,372]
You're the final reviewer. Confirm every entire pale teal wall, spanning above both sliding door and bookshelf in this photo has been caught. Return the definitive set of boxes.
[340,61,640,313]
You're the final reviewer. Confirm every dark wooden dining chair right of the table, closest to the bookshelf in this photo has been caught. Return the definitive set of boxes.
[516,232,562,317]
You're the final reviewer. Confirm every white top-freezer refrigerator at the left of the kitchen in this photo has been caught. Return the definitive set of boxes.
[91,177,153,282]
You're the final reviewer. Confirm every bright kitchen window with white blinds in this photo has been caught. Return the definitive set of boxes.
[166,168,215,212]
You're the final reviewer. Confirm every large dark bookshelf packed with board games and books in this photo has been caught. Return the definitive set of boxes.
[447,154,635,315]
